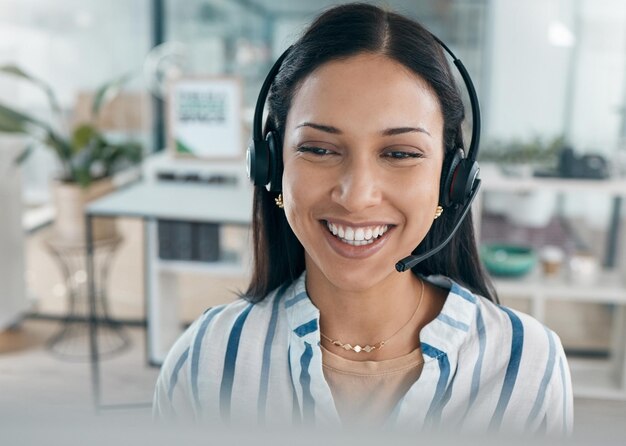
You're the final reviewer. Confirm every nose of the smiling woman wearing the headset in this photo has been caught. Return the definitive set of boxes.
[332,162,382,213]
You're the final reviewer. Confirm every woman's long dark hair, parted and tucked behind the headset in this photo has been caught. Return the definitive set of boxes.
[244,3,498,302]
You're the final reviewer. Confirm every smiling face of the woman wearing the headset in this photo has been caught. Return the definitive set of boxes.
[283,54,443,291]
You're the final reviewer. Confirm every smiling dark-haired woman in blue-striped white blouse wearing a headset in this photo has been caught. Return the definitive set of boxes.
[154,4,572,433]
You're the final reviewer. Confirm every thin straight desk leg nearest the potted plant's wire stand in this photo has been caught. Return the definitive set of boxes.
[85,215,102,412]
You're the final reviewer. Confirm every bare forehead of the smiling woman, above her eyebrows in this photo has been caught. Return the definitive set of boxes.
[287,53,443,133]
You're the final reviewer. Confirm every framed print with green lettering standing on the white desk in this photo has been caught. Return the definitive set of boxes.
[168,77,244,160]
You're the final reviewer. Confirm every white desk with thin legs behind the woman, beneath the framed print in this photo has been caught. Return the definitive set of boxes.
[85,179,253,407]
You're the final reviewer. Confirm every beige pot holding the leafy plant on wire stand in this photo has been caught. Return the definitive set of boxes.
[52,178,117,245]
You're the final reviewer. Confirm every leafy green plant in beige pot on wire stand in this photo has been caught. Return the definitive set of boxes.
[0,65,142,244]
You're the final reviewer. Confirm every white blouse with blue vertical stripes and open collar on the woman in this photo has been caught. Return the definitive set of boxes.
[153,274,573,434]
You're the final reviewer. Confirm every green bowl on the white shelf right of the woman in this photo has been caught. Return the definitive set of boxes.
[480,243,537,277]
